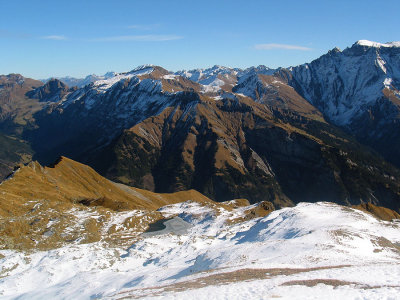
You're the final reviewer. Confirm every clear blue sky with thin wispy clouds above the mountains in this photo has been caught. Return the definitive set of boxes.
[0,0,400,78]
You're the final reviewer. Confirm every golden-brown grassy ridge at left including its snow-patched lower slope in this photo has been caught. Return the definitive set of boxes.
[0,157,222,250]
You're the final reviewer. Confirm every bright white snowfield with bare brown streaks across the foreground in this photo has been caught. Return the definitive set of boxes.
[0,202,400,299]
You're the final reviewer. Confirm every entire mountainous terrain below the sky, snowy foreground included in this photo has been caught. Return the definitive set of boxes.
[0,40,400,300]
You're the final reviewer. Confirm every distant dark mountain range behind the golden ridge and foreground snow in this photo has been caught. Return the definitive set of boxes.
[0,41,400,211]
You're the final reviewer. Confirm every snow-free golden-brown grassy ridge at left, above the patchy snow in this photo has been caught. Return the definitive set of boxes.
[0,157,216,216]
